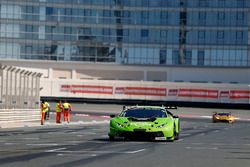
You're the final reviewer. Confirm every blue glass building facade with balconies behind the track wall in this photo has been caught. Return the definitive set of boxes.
[0,0,250,68]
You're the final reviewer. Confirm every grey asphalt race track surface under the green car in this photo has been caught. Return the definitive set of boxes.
[0,105,250,167]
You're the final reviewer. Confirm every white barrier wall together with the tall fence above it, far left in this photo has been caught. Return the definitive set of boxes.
[0,64,42,127]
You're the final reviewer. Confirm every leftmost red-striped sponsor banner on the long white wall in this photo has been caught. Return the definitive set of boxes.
[61,85,113,94]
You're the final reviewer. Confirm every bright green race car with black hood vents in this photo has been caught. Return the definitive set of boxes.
[108,106,180,141]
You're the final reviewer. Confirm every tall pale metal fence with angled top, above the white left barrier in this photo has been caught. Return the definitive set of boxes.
[0,64,42,109]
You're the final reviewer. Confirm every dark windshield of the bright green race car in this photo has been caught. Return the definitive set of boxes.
[123,108,167,118]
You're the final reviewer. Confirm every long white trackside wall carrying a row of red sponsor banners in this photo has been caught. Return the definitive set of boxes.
[41,79,250,104]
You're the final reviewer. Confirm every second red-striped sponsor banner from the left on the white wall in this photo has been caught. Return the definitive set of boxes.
[115,87,167,96]
